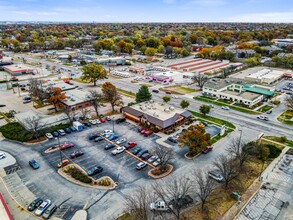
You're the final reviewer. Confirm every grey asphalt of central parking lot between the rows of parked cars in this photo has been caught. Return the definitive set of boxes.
[43,119,164,183]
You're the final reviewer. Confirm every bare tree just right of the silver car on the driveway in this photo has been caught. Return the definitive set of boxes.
[213,154,239,189]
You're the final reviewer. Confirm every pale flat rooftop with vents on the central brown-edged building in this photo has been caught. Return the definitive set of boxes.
[131,101,186,121]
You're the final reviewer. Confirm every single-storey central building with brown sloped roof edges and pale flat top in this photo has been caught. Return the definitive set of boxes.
[122,100,192,131]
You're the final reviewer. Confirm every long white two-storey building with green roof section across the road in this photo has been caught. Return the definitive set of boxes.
[203,79,274,106]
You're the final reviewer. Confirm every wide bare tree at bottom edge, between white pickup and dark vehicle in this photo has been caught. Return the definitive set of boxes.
[152,177,193,220]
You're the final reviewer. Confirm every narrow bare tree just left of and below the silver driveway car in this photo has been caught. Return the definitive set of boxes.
[194,170,216,211]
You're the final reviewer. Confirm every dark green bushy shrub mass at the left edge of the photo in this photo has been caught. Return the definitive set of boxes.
[0,122,31,142]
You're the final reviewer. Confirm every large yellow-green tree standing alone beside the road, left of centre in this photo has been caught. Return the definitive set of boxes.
[81,63,107,86]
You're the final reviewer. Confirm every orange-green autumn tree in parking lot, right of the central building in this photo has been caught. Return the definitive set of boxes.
[178,124,211,156]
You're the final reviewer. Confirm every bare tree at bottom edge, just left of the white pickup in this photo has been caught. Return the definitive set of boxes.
[125,186,151,220]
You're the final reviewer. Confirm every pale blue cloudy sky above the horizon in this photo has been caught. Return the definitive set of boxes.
[0,0,293,23]
